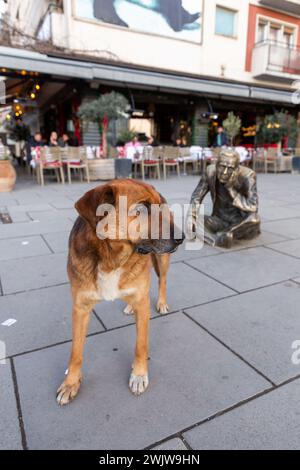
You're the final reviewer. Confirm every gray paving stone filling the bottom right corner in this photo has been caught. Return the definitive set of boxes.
[184,380,300,450]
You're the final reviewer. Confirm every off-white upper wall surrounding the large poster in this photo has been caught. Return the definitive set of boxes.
[10,0,296,86]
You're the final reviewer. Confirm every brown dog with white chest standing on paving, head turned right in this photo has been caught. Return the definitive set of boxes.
[57,180,184,405]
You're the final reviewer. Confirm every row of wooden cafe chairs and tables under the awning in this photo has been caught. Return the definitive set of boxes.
[4,145,300,185]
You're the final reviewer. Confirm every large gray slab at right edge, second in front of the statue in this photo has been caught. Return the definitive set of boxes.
[186,282,300,384]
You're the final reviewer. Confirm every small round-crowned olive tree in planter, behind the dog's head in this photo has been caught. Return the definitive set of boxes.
[78,91,129,158]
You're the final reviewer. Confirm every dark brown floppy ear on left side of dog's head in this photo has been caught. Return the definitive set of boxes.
[75,184,115,229]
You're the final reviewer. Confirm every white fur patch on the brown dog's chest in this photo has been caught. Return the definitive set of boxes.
[98,268,135,301]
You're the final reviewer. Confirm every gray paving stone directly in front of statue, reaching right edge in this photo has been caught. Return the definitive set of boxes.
[187,247,300,292]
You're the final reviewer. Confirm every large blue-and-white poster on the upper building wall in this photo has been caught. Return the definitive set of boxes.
[75,0,203,43]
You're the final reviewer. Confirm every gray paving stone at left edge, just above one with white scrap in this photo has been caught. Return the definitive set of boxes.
[0,253,68,294]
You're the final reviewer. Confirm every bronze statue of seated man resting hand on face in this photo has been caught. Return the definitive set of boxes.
[191,149,260,248]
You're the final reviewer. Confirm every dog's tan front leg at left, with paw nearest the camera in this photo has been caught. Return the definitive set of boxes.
[56,298,95,405]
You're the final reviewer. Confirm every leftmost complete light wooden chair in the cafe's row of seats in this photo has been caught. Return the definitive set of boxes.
[36,147,65,186]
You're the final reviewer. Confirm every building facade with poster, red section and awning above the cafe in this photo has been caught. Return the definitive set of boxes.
[0,0,300,145]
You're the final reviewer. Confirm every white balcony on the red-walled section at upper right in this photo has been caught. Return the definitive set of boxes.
[252,41,300,83]
